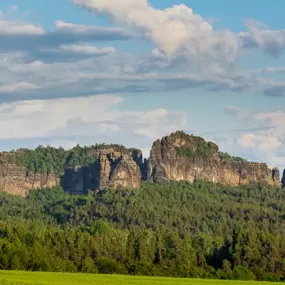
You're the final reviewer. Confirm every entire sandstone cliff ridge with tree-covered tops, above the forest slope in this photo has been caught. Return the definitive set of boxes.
[0,131,285,196]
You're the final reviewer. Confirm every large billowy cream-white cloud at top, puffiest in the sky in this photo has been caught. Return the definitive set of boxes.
[73,0,238,65]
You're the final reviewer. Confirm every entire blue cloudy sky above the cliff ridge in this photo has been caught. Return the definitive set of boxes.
[0,0,285,169]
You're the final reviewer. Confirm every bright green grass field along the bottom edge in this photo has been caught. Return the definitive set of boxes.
[0,271,276,285]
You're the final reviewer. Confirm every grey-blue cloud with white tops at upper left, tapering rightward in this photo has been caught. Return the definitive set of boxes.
[0,12,133,56]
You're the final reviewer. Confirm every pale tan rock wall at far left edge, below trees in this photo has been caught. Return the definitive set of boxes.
[0,160,59,197]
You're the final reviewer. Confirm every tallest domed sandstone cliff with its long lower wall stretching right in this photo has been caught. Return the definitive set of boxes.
[148,132,280,187]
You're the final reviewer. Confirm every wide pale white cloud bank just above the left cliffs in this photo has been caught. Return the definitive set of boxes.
[0,95,186,151]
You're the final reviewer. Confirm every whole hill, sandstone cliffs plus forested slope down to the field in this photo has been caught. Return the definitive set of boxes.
[0,132,285,281]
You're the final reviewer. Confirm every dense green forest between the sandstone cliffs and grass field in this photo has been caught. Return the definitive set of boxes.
[0,181,285,281]
